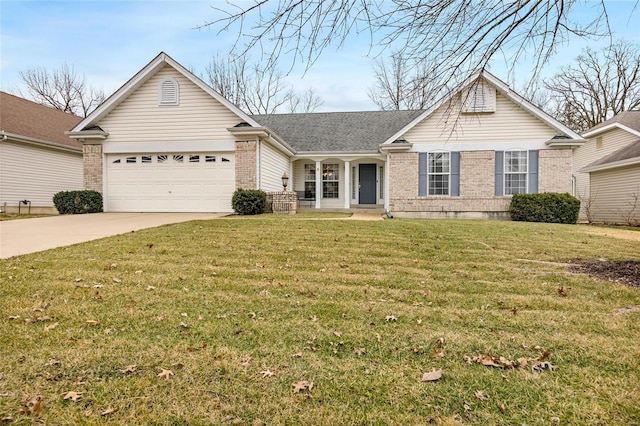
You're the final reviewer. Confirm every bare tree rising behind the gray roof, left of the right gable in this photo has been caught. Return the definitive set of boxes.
[369,52,439,110]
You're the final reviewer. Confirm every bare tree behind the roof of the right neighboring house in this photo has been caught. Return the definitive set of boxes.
[544,41,640,132]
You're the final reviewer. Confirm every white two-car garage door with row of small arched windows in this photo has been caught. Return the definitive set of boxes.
[105,152,235,212]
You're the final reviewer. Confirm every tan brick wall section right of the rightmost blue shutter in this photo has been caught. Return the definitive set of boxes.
[538,148,573,194]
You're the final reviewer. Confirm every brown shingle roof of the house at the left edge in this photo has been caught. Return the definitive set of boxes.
[0,92,82,150]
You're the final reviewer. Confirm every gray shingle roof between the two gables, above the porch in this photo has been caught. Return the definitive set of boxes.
[251,110,423,152]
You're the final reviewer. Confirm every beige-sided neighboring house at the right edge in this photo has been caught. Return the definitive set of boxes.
[574,111,640,224]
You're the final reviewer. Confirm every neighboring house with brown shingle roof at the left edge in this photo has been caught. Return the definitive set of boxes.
[0,92,83,213]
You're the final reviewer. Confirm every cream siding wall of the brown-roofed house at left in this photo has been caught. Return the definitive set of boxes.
[0,140,83,207]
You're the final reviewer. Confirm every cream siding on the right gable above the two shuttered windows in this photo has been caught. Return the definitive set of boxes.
[403,89,557,144]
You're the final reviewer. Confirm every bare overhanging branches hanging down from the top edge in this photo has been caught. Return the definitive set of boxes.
[201,0,611,90]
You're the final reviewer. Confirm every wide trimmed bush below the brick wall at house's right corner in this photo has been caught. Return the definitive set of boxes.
[509,192,580,224]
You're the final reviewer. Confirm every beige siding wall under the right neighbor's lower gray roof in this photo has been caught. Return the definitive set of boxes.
[591,165,640,224]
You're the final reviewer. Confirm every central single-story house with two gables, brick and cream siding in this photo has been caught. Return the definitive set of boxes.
[69,53,584,217]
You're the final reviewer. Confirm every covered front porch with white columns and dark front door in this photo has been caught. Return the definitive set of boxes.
[290,154,388,212]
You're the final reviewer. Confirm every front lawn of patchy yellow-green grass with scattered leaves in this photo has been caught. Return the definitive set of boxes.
[0,216,640,425]
